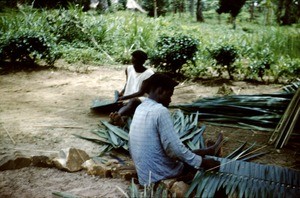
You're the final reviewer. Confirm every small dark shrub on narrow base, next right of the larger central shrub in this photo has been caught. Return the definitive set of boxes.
[209,45,238,79]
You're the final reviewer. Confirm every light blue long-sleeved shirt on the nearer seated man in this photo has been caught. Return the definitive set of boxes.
[129,98,202,185]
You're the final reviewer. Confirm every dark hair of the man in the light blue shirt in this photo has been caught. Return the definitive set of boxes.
[144,73,178,92]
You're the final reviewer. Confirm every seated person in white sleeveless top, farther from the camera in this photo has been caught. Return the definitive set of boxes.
[109,50,154,126]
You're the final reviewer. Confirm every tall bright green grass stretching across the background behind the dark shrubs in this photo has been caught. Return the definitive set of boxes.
[0,6,300,78]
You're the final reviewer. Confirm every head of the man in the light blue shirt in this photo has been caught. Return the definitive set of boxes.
[147,73,178,107]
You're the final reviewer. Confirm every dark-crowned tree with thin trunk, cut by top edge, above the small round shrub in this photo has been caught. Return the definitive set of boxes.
[216,0,246,29]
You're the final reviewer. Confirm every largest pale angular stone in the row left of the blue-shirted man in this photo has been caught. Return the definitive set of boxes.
[53,148,90,172]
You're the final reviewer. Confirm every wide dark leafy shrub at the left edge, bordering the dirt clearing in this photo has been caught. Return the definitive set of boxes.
[0,33,59,65]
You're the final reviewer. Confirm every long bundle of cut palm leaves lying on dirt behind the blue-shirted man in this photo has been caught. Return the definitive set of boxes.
[172,93,294,131]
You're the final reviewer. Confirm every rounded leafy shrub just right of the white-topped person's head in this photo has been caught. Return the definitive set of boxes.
[150,35,199,74]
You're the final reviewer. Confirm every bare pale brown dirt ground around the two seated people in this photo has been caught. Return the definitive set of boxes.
[0,63,299,197]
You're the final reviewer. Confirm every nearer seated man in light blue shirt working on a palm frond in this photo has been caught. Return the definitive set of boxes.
[129,74,223,185]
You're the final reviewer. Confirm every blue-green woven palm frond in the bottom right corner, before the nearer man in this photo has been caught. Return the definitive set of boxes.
[186,157,300,198]
